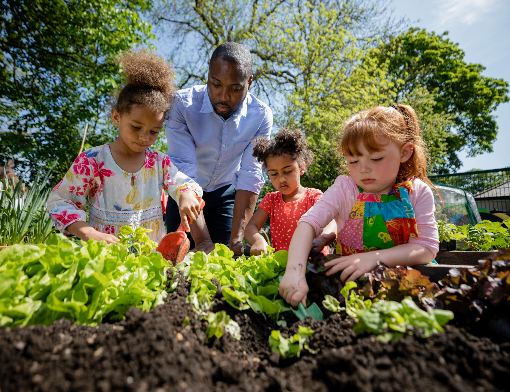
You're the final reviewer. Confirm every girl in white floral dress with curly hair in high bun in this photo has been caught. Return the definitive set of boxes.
[48,51,202,243]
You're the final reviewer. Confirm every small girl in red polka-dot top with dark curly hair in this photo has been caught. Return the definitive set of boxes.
[244,128,336,255]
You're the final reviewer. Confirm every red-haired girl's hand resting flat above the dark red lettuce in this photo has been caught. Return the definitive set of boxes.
[324,252,377,282]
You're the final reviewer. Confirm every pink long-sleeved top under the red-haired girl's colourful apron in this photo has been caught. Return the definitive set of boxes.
[299,176,439,257]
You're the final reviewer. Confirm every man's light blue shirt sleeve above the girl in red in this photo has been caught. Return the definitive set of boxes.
[232,108,273,194]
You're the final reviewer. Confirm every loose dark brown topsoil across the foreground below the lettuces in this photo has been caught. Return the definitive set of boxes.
[0,277,510,392]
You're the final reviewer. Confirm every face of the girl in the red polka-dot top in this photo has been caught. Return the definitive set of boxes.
[266,155,305,197]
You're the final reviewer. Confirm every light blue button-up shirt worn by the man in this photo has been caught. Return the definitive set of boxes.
[165,85,273,193]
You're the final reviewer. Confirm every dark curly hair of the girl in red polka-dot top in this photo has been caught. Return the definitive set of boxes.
[253,128,313,167]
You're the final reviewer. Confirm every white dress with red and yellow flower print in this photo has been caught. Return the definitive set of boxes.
[47,145,202,242]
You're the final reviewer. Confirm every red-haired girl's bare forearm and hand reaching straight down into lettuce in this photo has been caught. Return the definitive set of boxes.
[279,222,315,306]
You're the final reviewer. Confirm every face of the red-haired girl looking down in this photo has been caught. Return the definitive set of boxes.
[345,138,413,193]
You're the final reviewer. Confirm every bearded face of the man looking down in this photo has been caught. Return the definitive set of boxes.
[207,57,253,119]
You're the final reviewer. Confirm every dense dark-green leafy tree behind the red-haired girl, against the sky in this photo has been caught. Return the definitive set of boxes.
[372,28,509,173]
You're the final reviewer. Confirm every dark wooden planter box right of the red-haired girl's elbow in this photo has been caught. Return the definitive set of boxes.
[413,251,494,282]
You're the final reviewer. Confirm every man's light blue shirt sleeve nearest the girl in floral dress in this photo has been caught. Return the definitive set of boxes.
[165,97,198,182]
